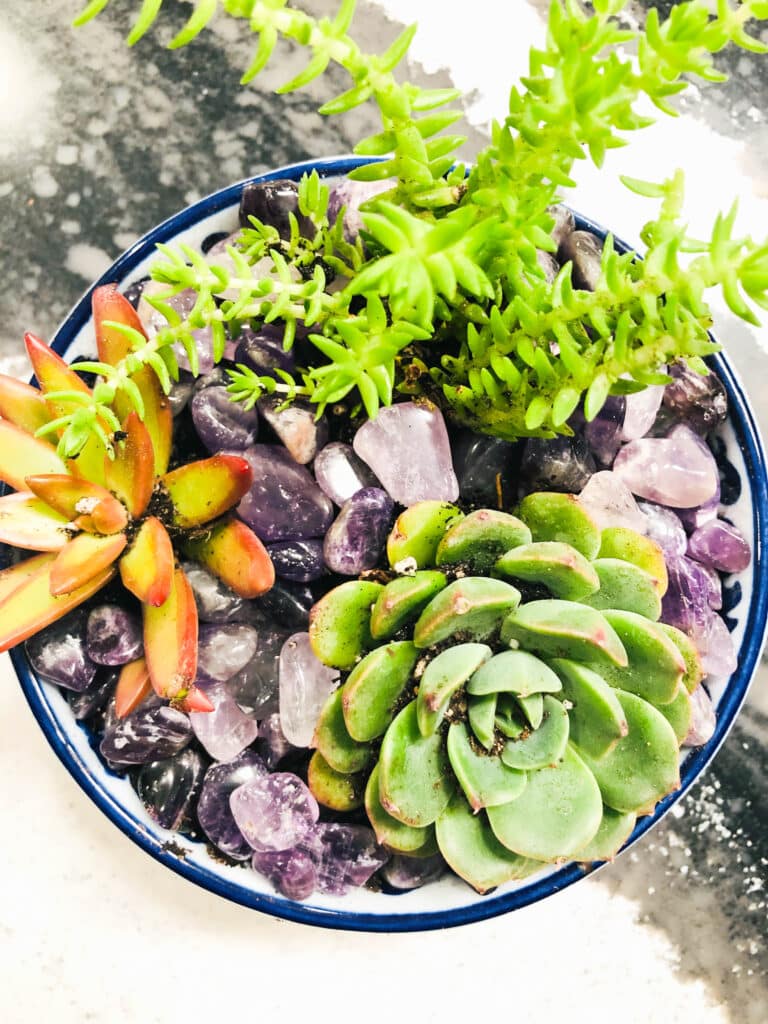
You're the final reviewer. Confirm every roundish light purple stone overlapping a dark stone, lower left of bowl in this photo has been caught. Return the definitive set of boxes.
[229,772,319,853]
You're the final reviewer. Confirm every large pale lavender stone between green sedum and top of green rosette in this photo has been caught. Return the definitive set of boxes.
[353,401,459,505]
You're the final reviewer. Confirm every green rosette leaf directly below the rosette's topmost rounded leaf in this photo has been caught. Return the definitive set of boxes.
[494,541,600,603]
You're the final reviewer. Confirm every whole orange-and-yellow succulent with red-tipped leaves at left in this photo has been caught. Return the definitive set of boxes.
[0,285,274,715]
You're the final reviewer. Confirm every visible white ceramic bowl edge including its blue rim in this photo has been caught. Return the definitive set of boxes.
[11,158,768,931]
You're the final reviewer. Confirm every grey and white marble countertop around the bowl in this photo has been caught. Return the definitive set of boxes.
[0,0,768,1024]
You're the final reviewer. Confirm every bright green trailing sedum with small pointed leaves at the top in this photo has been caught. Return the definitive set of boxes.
[61,0,768,455]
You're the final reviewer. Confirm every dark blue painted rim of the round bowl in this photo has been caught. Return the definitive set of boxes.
[10,157,768,932]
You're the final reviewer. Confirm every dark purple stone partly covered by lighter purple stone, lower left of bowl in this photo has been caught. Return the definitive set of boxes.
[198,751,267,860]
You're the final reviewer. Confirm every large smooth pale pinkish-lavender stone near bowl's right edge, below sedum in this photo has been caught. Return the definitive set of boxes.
[613,426,719,509]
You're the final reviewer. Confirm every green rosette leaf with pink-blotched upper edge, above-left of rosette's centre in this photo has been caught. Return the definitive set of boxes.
[414,577,520,647]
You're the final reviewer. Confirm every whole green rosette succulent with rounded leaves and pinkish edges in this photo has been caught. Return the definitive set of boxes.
[309,494,701,893]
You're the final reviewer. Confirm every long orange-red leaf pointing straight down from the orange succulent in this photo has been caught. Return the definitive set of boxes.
[142,569,198,700]
